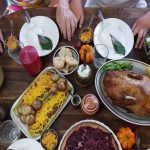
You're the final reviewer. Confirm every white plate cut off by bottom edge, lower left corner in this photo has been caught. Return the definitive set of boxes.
[8,138,44,150]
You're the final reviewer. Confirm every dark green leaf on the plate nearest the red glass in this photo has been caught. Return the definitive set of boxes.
[38,34,53,50]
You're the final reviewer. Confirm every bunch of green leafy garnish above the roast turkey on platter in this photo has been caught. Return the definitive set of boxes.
[103,61,133,71]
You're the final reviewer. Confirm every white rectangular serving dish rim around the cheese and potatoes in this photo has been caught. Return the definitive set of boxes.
[10,67,74,140]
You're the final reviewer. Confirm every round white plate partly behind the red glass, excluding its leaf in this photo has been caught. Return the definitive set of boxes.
[19,16,59,57]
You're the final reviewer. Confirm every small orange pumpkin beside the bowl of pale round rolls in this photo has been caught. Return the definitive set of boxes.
[79,44,93,63]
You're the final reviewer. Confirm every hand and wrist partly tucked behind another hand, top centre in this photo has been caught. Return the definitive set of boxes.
[70,0,84,28]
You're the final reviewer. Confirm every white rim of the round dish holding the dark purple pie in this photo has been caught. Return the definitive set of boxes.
[58,119,122,150]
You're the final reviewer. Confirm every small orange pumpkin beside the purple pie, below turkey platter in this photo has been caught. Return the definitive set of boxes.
[117,127,136,149]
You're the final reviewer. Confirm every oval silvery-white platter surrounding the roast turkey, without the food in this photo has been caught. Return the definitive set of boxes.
[95,58,150,126]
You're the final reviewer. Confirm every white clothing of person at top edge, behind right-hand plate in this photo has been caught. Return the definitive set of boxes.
[85,0,147,8]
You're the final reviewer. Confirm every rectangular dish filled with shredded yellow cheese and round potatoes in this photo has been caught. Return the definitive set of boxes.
[11,67,73,139]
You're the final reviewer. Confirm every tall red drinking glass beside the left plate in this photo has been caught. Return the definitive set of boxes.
[19,46,42,76]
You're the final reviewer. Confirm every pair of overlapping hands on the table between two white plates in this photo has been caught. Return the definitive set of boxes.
[56,0,84,41]
